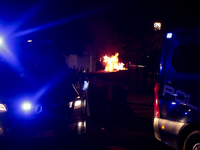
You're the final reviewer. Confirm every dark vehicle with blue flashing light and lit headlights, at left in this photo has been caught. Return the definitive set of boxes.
[0,39,86,145]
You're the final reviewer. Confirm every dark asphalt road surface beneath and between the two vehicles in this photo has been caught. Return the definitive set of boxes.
[2,104,173,150]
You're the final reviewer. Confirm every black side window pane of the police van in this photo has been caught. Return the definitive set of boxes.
[171,43,200,73]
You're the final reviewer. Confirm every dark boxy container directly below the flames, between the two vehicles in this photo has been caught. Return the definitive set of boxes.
[84,70,130,119]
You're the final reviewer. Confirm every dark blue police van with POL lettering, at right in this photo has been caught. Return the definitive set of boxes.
[153,28,200,150]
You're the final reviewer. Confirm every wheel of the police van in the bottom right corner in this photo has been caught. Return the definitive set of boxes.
[183,130,200,150]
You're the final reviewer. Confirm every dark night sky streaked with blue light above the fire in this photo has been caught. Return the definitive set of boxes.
[0,0,200,57]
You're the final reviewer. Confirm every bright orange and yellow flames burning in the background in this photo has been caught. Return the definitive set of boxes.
[103,53,125,71]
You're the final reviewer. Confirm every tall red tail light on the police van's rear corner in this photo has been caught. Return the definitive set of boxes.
[154,83,160,118]
